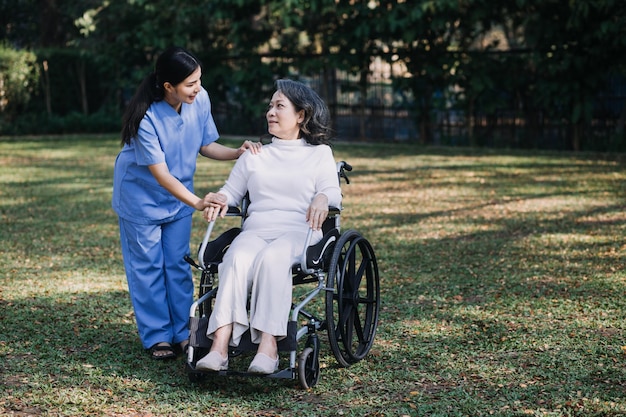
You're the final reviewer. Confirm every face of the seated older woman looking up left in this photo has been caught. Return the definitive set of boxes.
[265,91,304,140]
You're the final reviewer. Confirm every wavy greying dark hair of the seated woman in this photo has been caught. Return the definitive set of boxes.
[276,79,332,145]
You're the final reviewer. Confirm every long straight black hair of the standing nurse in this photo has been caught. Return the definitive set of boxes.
[122,46,200,145]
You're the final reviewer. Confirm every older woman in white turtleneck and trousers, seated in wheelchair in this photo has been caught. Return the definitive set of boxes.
[196,80,341,374]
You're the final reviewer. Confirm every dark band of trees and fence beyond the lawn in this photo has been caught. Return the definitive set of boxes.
[0,0,626,151]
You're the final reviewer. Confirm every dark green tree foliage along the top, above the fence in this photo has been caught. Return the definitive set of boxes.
[0,0,626,149]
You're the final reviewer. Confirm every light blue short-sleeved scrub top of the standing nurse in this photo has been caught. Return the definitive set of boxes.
[112,89,219,224]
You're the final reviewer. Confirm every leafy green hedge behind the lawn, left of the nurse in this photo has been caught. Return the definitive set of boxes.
[0,46,120,135]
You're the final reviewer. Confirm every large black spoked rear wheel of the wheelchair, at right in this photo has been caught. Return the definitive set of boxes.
[326,230,380,367]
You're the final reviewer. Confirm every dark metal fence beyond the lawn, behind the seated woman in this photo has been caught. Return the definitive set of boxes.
[216,65,626,149]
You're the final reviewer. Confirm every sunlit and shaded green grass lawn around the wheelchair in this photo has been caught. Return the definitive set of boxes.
[0,136,626,417]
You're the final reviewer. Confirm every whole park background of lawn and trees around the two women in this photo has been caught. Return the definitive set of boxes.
[0,0,626,417]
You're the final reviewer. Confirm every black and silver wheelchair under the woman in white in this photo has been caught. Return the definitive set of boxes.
[185,161,380,389]
